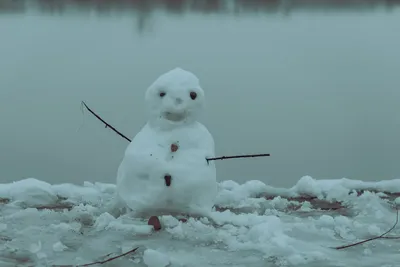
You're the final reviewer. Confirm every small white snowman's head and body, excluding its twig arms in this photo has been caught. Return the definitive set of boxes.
[117,68,217,224]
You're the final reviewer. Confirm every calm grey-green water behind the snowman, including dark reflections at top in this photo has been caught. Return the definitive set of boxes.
[0,0,400,186]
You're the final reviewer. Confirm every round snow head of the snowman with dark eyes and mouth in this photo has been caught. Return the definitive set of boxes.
[146,68,204,127]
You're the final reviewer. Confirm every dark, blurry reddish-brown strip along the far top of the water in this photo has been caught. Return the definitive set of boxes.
[0,0,400,14]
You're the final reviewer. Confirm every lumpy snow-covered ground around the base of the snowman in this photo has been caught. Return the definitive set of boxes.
[0,176,400,267]
